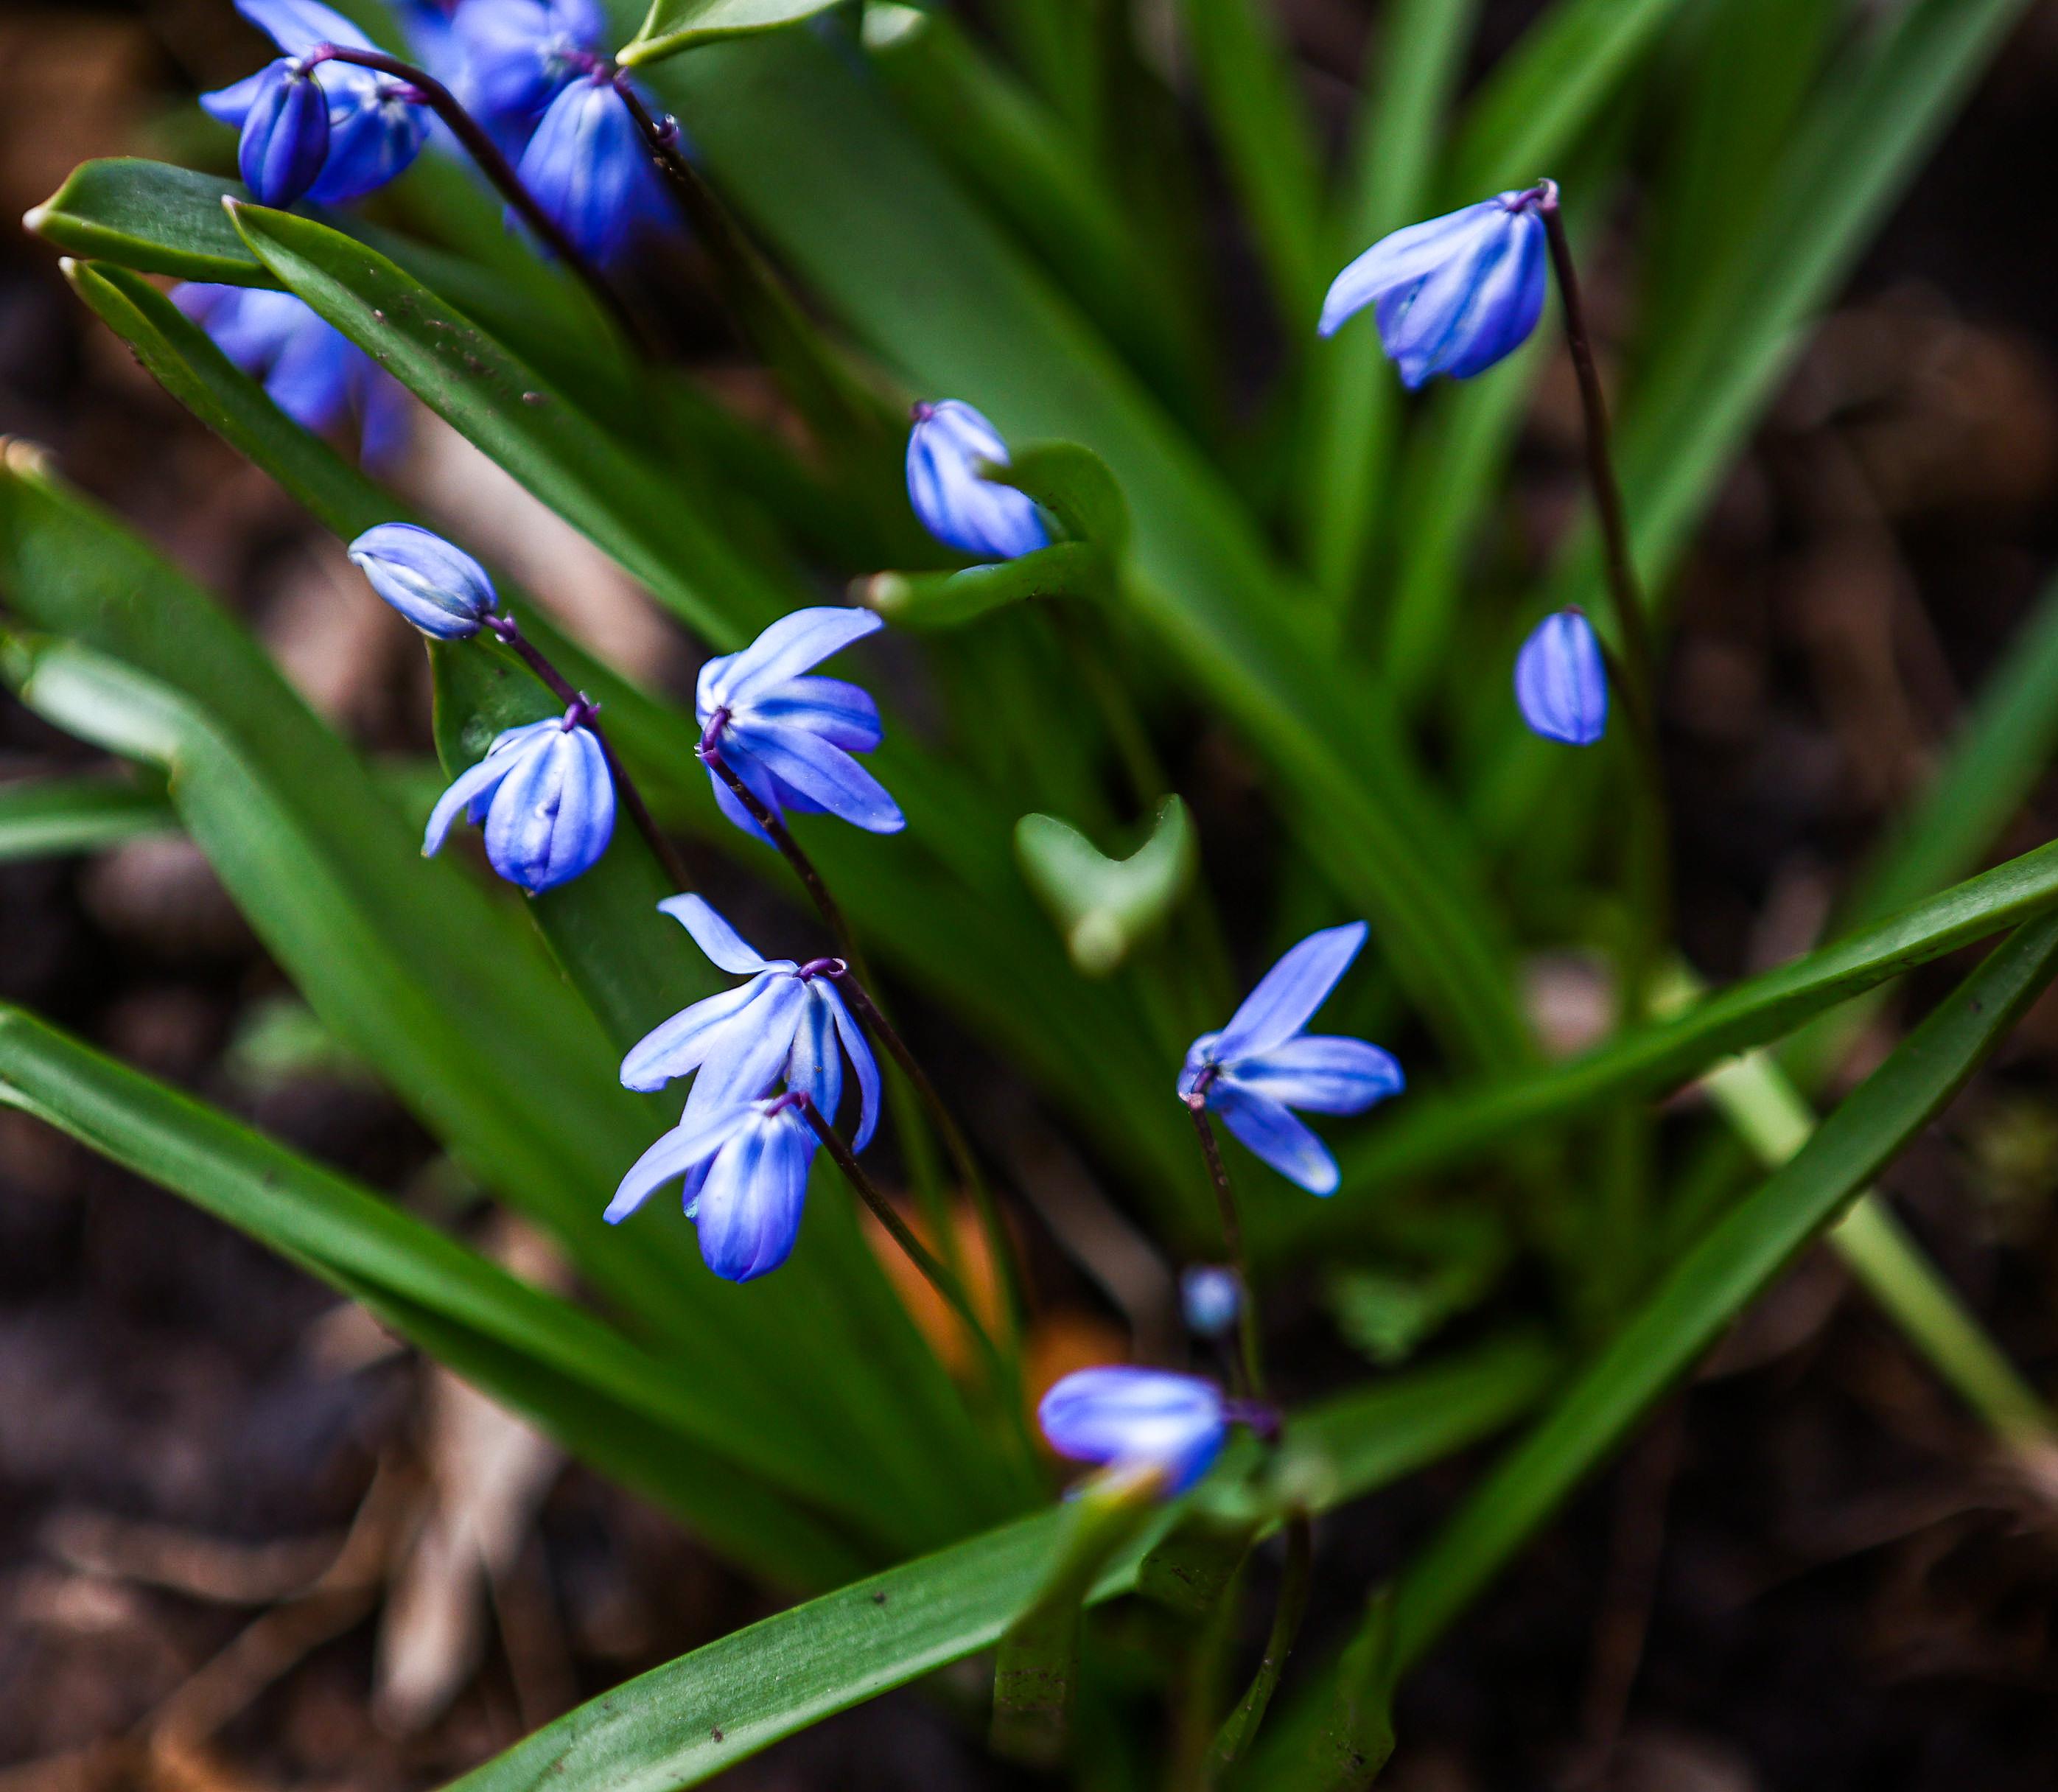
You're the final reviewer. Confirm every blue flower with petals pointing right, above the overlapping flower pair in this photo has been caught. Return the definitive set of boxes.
[696,605,908,839]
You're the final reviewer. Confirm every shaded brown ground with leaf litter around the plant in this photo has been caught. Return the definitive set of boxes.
[0,4,2058,1792]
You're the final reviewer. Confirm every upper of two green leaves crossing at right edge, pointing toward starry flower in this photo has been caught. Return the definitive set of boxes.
[1280,827,2058,1236]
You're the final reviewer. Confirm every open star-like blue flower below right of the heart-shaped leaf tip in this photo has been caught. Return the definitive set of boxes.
[1179,922,1406,1195]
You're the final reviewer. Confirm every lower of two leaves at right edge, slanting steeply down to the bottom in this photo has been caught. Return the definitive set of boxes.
[1251,917,2058,1792]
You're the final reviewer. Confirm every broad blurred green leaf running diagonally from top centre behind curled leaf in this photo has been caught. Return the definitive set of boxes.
[654,33,1531,1064]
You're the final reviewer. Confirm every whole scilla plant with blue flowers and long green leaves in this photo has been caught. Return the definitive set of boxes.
[0,0,2058,1792]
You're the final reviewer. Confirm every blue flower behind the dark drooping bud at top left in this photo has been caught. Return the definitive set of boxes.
[200,0,428,206]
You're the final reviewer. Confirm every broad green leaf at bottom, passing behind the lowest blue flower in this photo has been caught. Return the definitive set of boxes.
[434,1342,1554,1792]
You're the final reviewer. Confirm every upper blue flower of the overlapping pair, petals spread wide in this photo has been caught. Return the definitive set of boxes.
[605,895,879,1150]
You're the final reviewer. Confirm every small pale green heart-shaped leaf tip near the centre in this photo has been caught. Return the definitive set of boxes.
[1015,797,1200,977]
